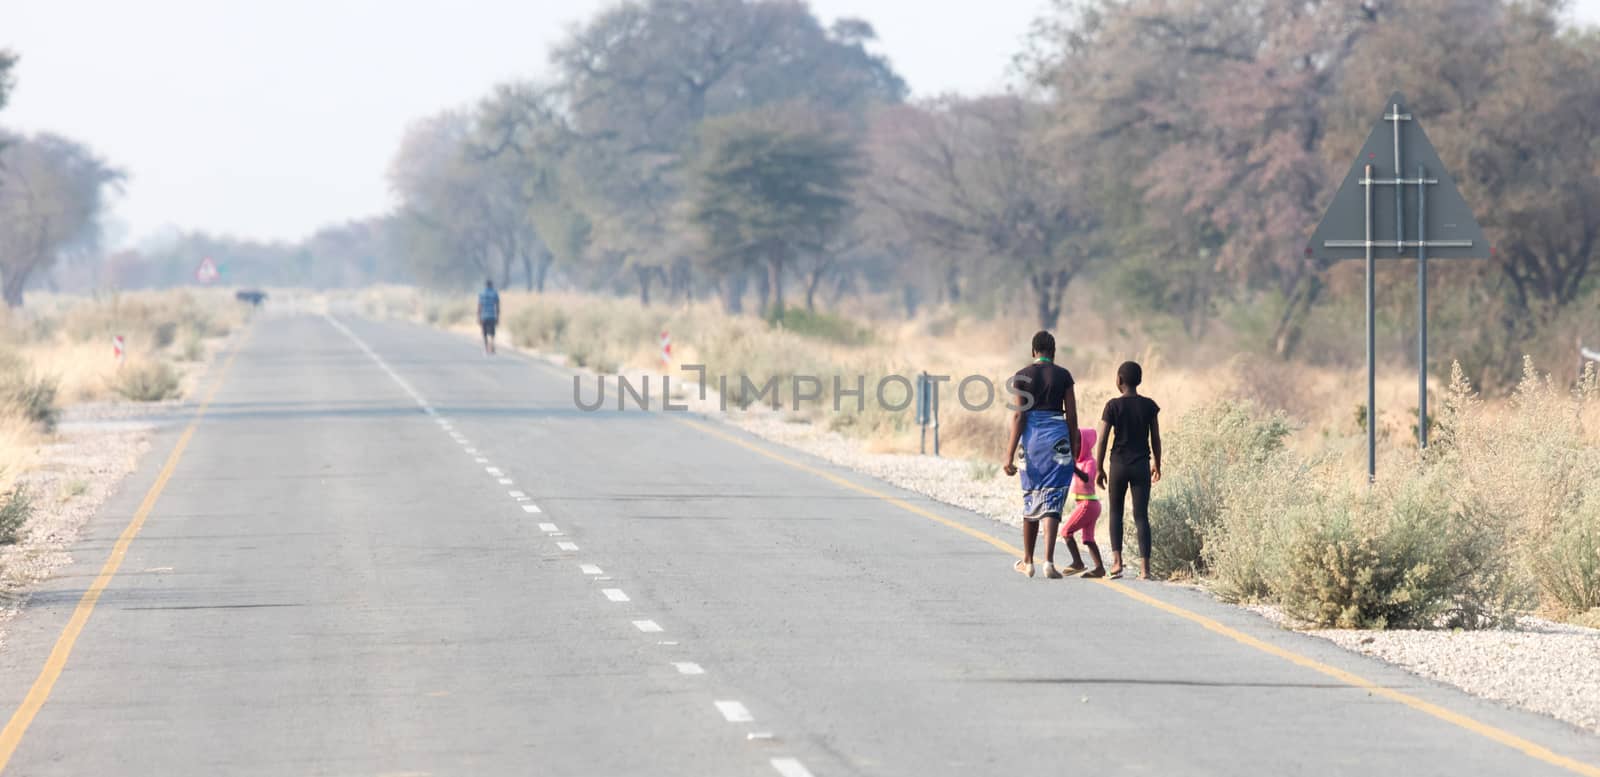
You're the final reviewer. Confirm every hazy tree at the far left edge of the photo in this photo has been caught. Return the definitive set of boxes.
[0,134,123,307]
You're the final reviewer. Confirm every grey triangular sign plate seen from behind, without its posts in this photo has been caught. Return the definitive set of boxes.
[1306,91,1490,261]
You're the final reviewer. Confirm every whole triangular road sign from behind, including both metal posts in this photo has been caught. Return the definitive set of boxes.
[1306,93,1493,480]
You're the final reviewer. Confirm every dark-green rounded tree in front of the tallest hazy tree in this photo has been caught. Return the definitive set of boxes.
[690,110,859,315]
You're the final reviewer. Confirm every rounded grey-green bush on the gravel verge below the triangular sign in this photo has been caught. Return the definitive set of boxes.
[1270,467,1528,628]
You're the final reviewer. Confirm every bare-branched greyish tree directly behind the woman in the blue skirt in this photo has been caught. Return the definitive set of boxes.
[869,96,1104,328]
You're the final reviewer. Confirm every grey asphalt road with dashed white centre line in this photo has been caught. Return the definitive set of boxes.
[0,315,1600,777]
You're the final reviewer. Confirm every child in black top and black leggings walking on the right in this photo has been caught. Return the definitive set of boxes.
[1094,361,1162,580]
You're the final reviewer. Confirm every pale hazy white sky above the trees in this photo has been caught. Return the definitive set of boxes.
[0,0,1600,246]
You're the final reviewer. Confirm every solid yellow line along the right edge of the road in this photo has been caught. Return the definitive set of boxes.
[677,419,1600,777]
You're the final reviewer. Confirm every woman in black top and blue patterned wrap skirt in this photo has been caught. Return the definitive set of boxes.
[1002,331,1078,579]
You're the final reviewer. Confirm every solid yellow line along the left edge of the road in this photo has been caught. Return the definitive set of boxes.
[0,329,250,772]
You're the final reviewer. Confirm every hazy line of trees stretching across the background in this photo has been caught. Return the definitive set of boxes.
[0,0,1600,382]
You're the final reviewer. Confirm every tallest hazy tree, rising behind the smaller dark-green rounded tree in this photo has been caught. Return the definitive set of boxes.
[552,0,906,299]
